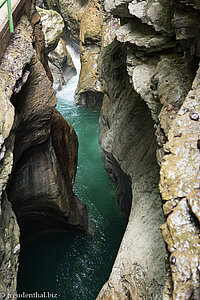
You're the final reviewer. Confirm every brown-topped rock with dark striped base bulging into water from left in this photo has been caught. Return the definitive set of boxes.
[8,12,87,238]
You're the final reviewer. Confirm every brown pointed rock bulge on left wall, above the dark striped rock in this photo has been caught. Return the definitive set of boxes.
[13,55,57,161]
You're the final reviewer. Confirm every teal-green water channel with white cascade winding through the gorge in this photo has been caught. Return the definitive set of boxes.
[18,45,125,300]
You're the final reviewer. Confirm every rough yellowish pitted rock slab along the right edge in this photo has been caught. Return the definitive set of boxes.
[160,70,200,299]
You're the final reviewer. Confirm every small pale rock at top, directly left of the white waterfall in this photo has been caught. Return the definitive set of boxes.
[48,38,76,90]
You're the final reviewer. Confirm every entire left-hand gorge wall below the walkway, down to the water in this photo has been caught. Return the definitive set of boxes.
[0,1,88,299]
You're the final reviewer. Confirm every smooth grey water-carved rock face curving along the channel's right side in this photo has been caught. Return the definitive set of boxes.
[97,42,166,299]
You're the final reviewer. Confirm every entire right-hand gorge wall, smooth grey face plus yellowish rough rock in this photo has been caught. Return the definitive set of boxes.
[97,0,200,299]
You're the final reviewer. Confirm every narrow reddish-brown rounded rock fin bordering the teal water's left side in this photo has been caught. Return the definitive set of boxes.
[51,110,88,230]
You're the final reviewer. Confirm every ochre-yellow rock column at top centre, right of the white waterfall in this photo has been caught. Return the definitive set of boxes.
[43,0,119,107]
